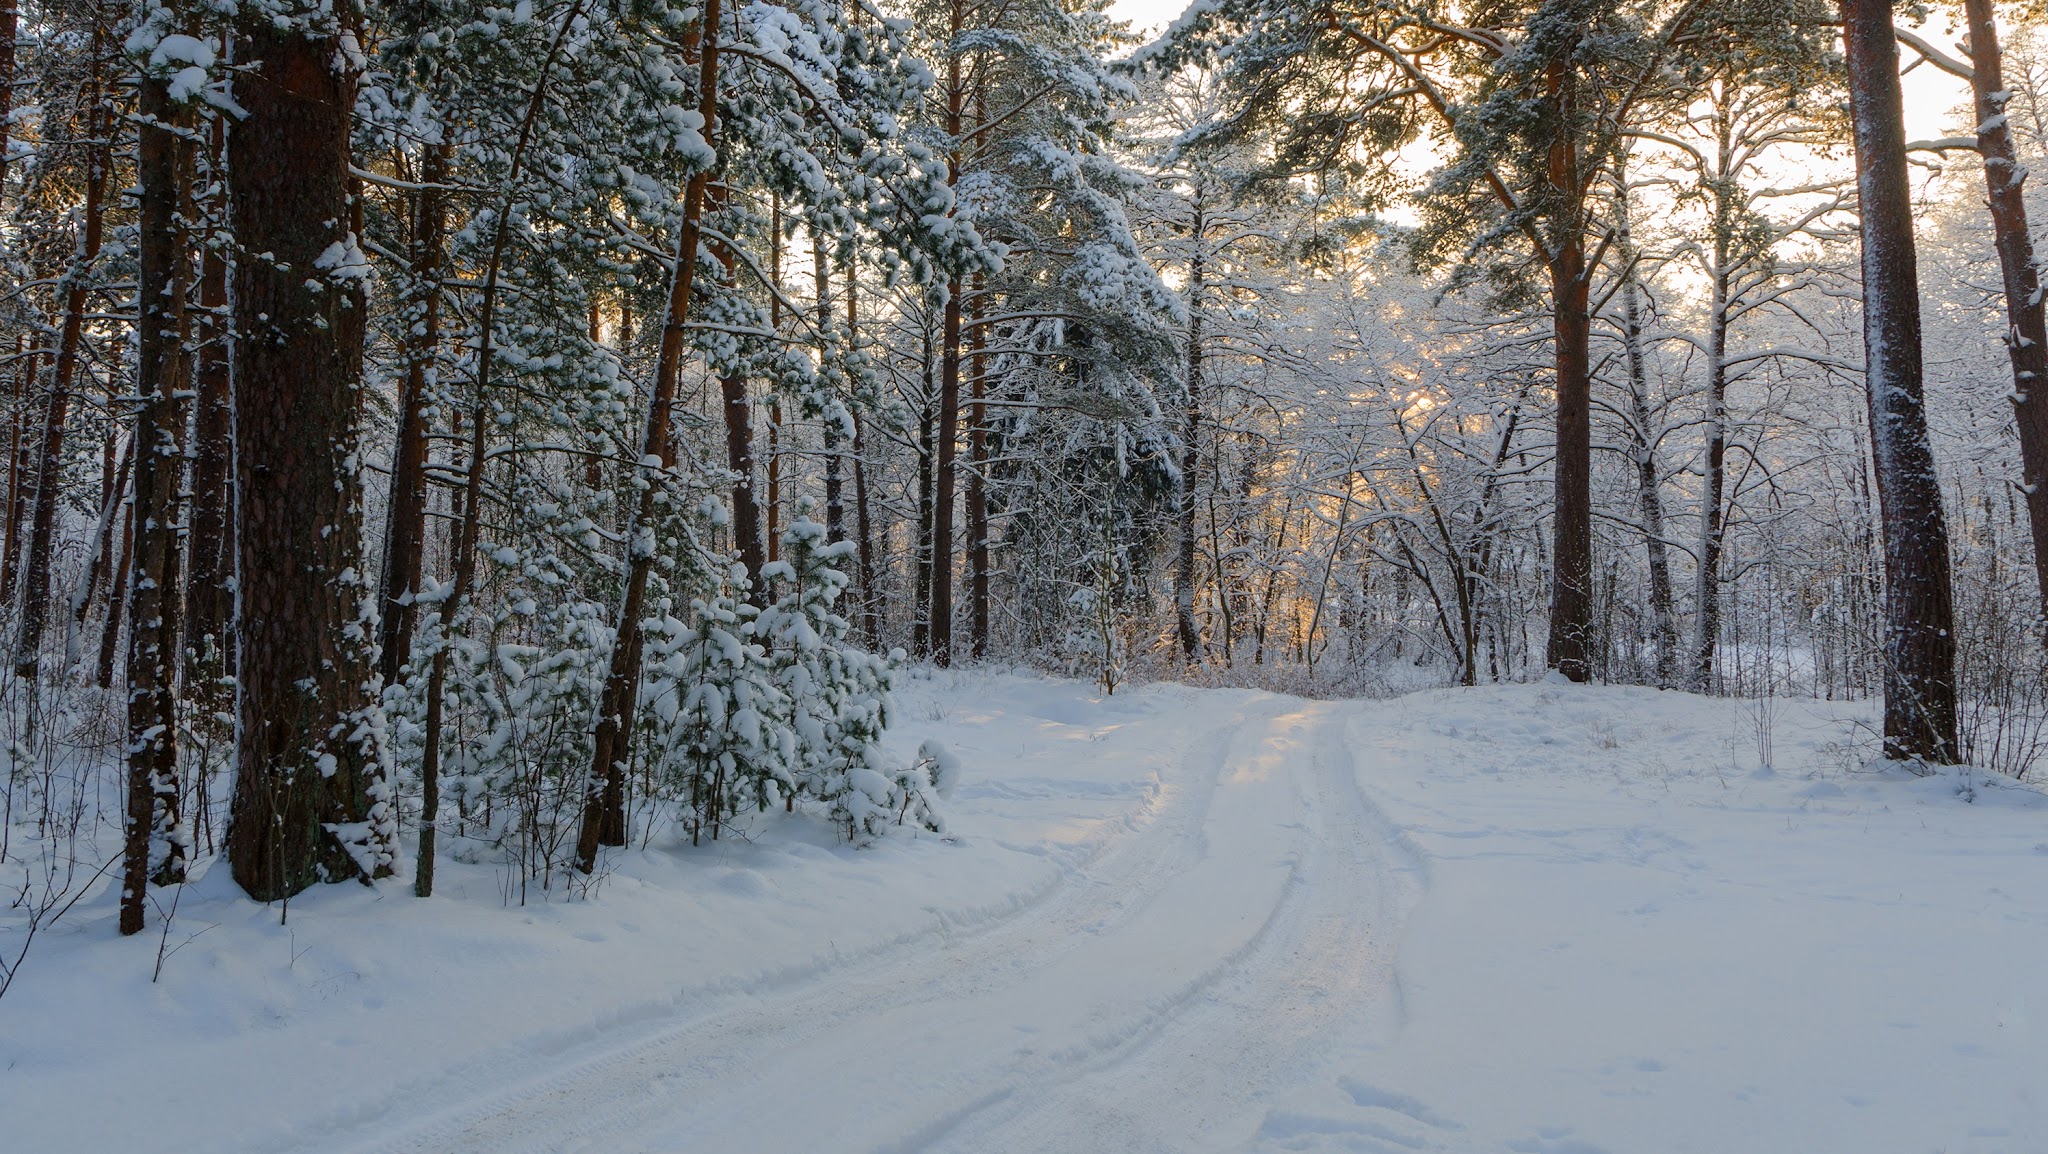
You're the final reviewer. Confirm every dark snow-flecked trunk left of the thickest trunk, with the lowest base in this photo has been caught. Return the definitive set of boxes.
[122,76,190,935]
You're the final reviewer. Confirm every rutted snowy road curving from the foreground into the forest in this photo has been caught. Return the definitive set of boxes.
[322,697,1419,1152]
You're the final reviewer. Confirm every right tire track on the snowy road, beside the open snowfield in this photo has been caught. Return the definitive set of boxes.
[921,705,1425,1152]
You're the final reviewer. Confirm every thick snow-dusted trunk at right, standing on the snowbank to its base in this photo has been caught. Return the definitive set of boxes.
[1841,0,1958,765]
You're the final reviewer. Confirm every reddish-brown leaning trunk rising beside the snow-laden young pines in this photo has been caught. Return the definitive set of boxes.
[575,0,729,873]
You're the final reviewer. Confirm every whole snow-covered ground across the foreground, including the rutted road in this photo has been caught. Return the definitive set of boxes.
[0,674,2048,1154]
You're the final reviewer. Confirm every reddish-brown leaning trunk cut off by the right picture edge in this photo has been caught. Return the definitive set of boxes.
[1962,0,2048,631]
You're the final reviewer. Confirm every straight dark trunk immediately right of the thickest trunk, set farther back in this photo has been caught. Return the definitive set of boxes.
[377,141,449,685]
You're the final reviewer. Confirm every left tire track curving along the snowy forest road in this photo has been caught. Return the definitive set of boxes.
[290,697,1286,1154]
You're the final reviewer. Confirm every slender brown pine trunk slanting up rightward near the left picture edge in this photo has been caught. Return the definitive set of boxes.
[14,38,109,676]
